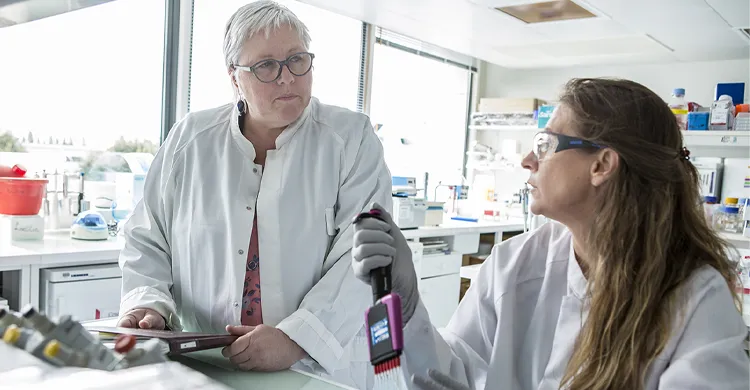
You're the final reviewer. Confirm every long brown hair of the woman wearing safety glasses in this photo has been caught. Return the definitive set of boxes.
[560,79,739,390]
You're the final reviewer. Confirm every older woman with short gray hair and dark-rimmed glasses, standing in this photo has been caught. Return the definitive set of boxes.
[119,1,391,387]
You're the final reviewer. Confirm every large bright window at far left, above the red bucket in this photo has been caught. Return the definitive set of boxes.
[0,0,165,210]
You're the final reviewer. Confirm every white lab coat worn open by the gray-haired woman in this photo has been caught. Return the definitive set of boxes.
[120,98,391,387]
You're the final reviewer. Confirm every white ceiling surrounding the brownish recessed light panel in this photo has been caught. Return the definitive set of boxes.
[299,0,750,68]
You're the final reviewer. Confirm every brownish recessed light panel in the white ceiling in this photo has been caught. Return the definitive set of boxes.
[495,0,596,23]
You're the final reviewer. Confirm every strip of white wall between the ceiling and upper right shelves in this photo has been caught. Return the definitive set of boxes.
[482,60,750,106]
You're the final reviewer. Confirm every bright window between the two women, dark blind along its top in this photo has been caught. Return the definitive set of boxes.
[370,29,473,200]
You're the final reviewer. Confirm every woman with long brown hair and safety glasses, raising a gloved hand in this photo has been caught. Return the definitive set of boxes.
[352,79,750,390]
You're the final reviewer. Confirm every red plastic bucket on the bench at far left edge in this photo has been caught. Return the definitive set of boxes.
[0,177,49,215]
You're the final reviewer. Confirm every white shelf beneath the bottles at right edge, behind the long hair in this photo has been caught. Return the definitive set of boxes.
[682,130,750,158]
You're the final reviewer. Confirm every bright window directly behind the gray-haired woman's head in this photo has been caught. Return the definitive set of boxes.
[189,0,362,111]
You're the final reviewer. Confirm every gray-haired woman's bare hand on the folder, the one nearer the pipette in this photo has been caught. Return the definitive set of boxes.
[221,325,307,371]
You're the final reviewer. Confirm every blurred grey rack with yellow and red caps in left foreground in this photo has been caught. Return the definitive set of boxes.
[0,305,166,371]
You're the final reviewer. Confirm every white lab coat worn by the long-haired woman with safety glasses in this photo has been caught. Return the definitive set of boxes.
[403,222,750,390]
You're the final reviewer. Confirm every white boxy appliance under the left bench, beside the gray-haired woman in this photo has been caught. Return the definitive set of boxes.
[39,263,122,321]
